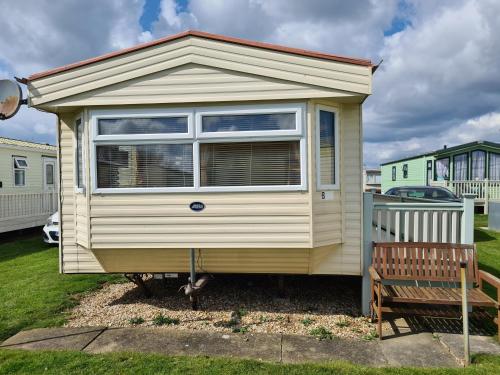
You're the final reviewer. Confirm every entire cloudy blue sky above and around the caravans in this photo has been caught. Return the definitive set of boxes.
[0,0,500,167]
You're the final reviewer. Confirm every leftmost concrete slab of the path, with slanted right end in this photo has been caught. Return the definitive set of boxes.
[0,327,106,350]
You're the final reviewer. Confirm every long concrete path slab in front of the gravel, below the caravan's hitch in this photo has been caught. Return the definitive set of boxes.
[85,328,281,362]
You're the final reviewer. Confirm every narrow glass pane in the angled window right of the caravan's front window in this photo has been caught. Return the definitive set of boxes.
[319,111,335,185]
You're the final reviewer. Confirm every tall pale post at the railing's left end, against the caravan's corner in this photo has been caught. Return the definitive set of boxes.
[361,193,373,316]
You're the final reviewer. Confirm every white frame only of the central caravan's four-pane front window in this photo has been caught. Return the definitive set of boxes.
[90,103,307,194]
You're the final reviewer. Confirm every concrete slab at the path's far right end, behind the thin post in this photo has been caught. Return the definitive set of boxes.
[437,333,500,363]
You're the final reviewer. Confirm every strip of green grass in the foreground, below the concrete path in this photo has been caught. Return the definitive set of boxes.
[0,350,500,375]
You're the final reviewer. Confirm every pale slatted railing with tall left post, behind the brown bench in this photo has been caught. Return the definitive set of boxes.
[362,193,474,314]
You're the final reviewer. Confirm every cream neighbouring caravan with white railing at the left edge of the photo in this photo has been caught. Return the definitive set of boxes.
[0,137,58,233]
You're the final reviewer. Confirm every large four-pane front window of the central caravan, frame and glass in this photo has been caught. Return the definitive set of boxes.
[91,104,306,193]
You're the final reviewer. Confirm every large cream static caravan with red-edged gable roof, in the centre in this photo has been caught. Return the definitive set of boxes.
[26,31,375,275]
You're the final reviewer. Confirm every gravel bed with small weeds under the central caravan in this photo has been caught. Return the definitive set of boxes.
[67,275,373,339]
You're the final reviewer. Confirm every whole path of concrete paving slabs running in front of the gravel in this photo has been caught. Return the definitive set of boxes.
[0,327,488,367]
